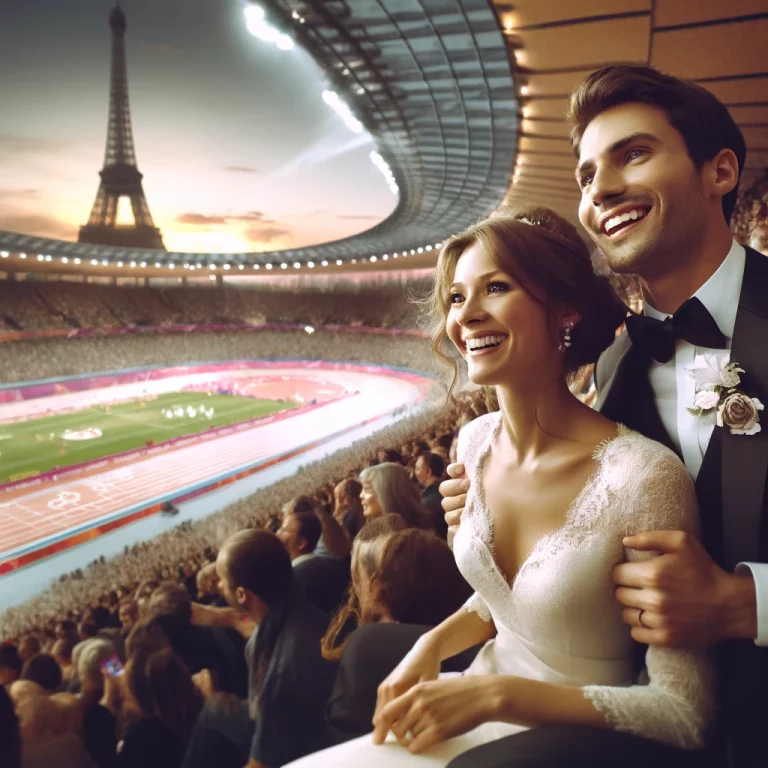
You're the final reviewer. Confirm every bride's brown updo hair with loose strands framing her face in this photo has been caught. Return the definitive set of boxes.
[431,206,627,388]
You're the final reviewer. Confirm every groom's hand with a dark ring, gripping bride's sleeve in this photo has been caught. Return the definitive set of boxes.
[613,531,757,648]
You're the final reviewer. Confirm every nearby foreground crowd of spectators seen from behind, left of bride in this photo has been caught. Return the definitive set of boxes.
[0,391,487,768]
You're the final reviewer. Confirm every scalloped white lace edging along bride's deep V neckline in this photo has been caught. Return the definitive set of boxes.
[475,411,632,591]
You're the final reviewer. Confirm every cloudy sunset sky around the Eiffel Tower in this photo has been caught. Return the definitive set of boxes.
[0,0,397,251]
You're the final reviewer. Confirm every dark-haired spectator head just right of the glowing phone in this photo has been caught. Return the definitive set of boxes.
[125,648,202,743]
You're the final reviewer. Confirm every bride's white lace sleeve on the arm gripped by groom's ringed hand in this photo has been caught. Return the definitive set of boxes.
[583,444,714,748]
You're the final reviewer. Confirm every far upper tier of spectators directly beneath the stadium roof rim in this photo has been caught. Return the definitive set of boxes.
[0,278,427,331]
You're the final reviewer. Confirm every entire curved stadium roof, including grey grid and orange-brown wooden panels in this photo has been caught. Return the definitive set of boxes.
[0,0,768,276]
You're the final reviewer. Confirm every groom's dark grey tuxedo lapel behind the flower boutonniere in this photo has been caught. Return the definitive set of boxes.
[719,248,768,570]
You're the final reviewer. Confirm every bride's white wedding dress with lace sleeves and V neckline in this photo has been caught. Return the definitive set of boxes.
[291,412,714,768]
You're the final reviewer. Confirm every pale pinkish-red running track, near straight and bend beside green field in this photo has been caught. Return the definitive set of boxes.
[0,365,432,574]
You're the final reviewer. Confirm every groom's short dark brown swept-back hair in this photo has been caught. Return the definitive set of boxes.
[568,64,747,222]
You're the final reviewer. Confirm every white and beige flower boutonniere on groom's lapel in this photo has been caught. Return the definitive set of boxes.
[687,353,764,435]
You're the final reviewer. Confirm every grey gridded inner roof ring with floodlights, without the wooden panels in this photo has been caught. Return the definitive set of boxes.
[0,0,518,267]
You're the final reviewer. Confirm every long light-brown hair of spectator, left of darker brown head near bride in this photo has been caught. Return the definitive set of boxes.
[322,514,408,661]
